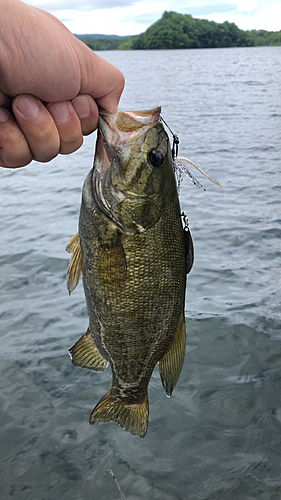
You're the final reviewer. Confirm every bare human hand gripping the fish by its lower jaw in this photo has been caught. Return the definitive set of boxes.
[0,0,124,168]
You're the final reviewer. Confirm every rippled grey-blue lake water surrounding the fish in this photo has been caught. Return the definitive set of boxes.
[0,47,281,500]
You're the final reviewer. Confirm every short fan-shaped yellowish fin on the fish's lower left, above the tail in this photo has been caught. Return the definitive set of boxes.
[68,328,108,372]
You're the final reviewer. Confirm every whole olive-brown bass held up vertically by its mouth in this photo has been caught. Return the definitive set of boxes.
[66,106,194,438]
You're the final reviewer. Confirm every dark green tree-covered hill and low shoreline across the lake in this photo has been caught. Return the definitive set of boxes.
[76,11,281,50]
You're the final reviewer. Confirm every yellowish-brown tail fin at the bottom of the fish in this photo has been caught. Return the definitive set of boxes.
[90,388,149,438]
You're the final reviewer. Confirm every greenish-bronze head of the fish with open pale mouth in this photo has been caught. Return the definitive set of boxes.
[92,107,174,235]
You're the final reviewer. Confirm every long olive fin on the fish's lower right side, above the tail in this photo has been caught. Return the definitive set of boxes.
[159,314,186,396]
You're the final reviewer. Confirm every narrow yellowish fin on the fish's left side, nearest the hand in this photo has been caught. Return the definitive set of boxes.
[66,233,82,295]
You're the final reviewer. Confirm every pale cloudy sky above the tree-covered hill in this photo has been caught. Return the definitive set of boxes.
[25,0,281,35]
